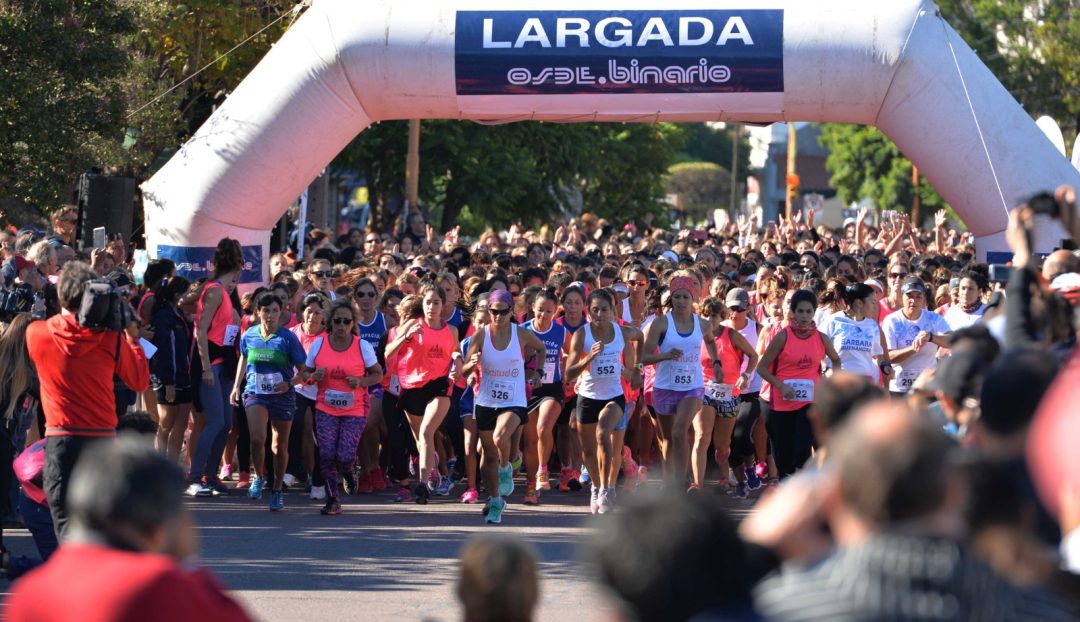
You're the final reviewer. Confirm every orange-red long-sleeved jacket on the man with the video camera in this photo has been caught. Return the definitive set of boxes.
[26,313,150,436]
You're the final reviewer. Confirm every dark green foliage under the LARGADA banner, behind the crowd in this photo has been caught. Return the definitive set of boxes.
[334,121,683,233]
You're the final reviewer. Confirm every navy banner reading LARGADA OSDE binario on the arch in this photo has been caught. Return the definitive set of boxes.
[455,9,784,95]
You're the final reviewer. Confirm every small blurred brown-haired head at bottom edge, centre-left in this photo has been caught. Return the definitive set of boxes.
[457,536,540,622]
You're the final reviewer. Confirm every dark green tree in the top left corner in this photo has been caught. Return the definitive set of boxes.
[0,0,135,218]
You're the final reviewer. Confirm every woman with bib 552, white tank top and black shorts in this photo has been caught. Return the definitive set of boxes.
[566,289,642,514]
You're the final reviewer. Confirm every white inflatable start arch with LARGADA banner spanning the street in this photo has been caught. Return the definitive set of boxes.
[143,0,1080,283]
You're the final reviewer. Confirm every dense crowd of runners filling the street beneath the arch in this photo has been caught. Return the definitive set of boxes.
[0,187,1080,617]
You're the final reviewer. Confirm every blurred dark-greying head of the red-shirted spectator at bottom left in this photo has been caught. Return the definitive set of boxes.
[68,434,195,559]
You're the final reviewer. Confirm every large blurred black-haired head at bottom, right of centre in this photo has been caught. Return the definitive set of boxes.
[590,493,752,622]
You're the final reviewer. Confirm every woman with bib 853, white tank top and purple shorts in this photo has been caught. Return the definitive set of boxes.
[643,272,724,486]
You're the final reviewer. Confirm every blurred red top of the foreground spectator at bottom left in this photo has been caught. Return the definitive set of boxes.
[6,543,249,622]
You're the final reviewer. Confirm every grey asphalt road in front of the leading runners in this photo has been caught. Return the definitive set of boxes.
[4,472,750,621]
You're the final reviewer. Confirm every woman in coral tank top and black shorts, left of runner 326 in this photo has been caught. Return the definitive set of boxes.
[387,282,461,504]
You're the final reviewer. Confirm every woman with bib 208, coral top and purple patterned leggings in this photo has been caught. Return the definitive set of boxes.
[301,298,382,516]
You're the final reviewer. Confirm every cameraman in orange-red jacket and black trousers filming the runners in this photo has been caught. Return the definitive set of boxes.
[26,261,150,537]
